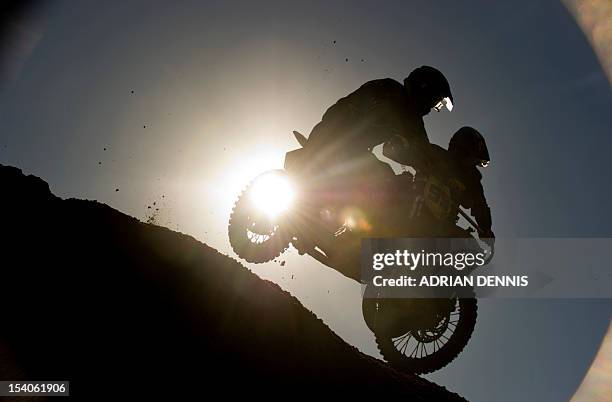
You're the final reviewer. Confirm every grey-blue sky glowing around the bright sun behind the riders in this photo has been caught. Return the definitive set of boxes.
[0,1,612,401]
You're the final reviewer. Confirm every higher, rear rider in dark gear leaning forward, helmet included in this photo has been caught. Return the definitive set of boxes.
[306,66,453,169]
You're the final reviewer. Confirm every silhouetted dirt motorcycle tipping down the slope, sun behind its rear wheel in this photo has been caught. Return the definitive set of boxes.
[228,132,490,373]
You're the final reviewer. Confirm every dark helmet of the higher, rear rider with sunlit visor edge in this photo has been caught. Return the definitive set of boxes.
[404,66,453,115]
